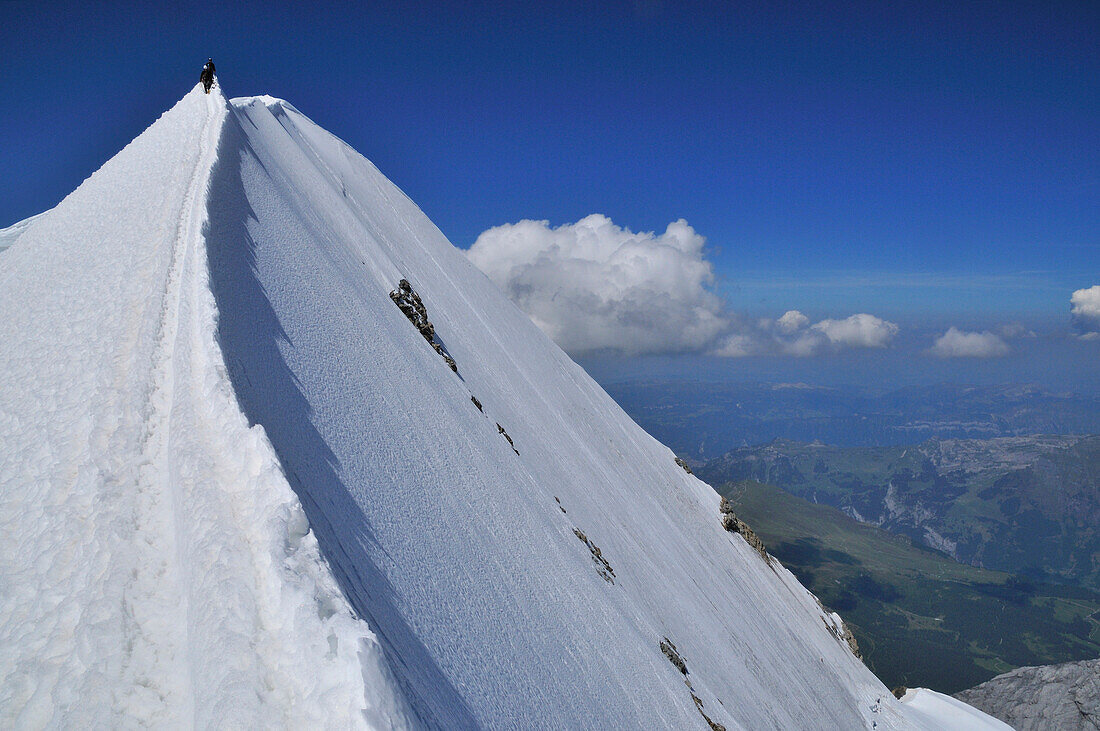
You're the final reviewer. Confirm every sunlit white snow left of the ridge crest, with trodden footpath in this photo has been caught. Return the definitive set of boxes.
[0,84,409,729]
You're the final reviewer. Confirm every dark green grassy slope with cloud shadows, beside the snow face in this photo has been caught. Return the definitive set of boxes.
[718,481,1100,693]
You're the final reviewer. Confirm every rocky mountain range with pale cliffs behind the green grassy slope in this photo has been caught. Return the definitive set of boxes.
[696,435,1100,588]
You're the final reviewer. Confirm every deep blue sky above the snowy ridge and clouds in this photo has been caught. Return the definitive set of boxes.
[0,0,1100,322]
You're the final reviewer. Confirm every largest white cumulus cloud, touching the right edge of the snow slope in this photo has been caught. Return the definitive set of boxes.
[468,214,738,355]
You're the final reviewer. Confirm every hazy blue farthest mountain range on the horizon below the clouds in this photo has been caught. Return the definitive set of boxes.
[605,380,1100,464]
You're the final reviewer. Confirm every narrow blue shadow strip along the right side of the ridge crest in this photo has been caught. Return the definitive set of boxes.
[207,108,480,728]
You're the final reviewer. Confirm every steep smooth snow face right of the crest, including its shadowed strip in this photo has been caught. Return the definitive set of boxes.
[209,97,1007,729]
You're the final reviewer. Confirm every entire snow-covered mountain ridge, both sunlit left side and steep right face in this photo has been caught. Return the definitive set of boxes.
[0,84,1007,729]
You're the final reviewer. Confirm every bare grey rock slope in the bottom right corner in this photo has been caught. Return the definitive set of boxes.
[955,660,1100,731]
